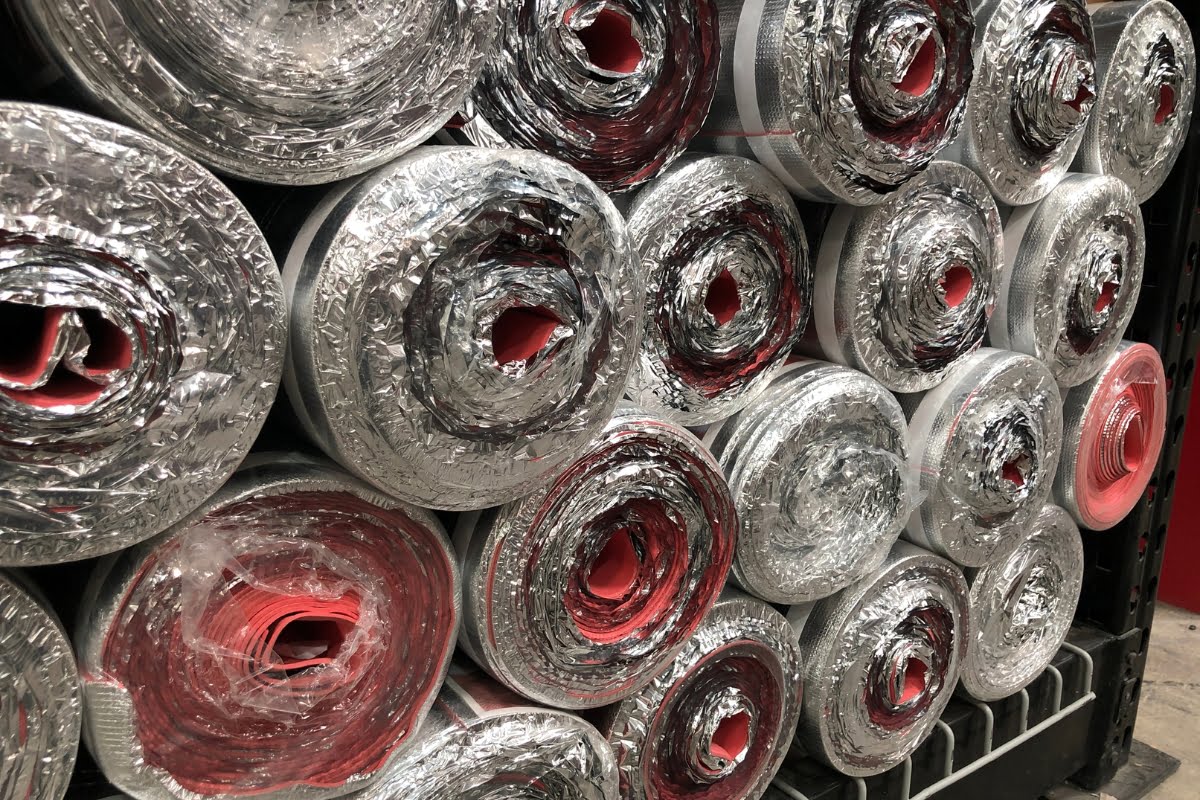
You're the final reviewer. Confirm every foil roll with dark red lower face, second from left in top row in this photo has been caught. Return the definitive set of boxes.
[463,0,720,192]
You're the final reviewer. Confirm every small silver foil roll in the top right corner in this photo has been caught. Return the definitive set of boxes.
[1076,0,1196,203]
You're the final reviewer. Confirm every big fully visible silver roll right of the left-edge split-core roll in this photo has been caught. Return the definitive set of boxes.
[284,148,643,509]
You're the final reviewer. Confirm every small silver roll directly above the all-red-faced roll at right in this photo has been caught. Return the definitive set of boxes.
[989,175,1146,387]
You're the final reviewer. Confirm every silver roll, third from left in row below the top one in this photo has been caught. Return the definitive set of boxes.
[625,156,812,426]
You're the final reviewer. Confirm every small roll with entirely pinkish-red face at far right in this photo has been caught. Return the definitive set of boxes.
[1054,342,1166,530]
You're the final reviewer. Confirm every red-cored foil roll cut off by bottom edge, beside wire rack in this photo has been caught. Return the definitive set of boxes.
[600,590,803,800]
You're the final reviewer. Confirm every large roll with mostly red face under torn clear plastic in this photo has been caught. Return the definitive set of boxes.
[76,457,460,800]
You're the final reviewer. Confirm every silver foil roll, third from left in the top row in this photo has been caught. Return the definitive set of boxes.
[703,0,974,205]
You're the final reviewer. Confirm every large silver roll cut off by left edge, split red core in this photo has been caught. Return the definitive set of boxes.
[0,103,286,565]
